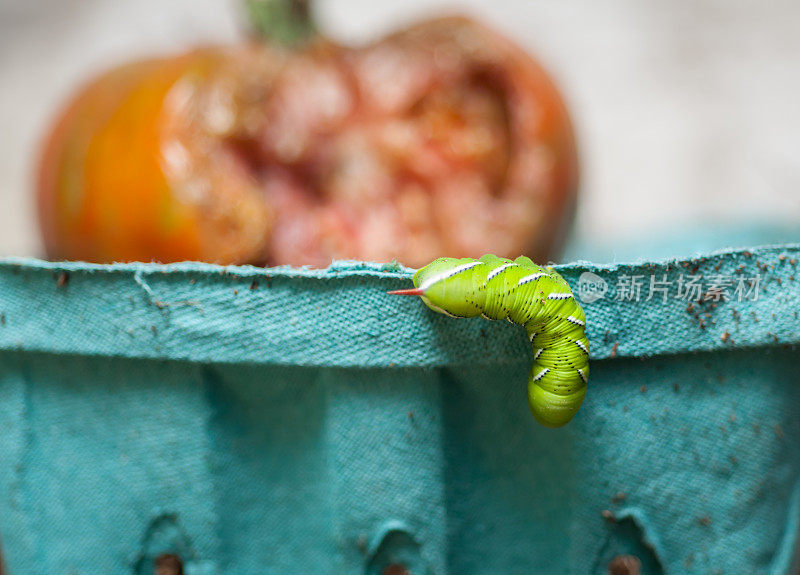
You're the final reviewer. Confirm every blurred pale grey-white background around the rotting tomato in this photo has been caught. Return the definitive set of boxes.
[0,0,800,260]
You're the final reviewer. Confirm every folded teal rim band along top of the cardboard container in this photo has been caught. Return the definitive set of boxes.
[0,244,800,368]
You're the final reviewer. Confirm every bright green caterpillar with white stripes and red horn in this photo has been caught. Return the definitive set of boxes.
[389,255,589,427]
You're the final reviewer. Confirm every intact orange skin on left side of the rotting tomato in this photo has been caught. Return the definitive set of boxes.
[37,49,271,264]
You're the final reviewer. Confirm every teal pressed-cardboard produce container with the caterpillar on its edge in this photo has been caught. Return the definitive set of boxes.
[0,245,800,575]
